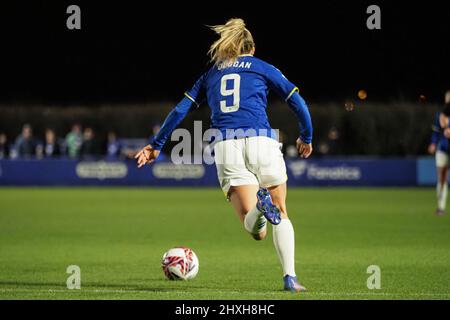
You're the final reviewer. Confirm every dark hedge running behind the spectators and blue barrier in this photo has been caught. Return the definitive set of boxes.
[0,100,442,157]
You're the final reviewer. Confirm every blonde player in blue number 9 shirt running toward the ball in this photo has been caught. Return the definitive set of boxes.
[136,19,312,292]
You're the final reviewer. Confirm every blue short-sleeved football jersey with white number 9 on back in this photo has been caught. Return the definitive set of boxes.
[185,55,298,138]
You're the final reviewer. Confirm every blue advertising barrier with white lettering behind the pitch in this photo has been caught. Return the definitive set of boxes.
[0,158,435,187]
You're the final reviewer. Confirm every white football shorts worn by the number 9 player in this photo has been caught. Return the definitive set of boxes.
[214,136,287,195]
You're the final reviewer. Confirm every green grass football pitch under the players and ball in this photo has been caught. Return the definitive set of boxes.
[0,188,450,299]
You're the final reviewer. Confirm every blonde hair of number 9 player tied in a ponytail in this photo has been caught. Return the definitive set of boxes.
[208,18,255,64]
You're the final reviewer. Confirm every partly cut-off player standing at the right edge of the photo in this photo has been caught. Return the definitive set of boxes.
[428,90,450,216]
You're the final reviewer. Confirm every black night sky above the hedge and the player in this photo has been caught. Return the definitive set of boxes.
[0,0,450,105]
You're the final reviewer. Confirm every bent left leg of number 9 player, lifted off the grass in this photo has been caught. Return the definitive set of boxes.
[228,185,267,240]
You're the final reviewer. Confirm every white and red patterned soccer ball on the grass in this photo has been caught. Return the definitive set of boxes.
[162,247,199,280]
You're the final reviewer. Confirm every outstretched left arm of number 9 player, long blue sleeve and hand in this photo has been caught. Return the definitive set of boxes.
[134,75,205,168]
